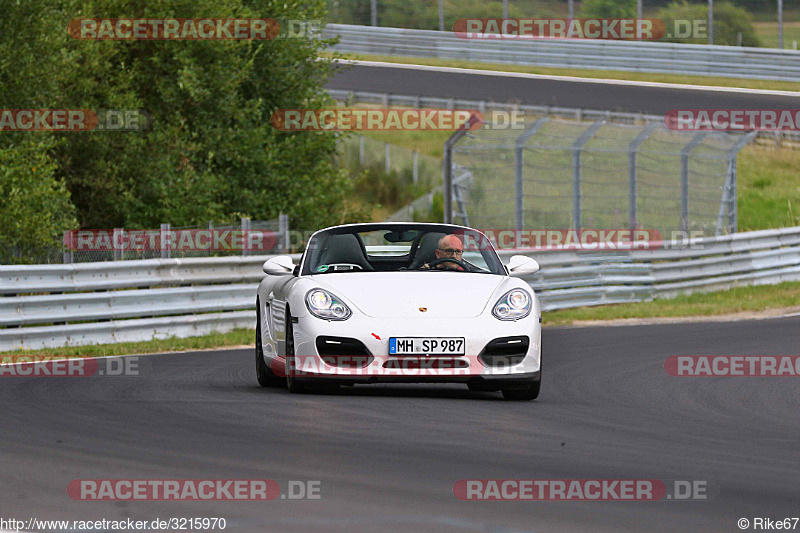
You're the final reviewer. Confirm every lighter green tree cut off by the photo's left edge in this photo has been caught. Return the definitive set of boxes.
[0,0,77,263]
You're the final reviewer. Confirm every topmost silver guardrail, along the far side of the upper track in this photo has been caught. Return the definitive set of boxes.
[323,24,800,81]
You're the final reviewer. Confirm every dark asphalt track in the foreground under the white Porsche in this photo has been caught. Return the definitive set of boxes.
[0,317,800,532]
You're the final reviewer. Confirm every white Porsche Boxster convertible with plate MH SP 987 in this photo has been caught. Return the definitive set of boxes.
[255,222,542,400]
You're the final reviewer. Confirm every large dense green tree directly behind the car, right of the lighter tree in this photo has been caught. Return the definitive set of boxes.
[58,0,349,227]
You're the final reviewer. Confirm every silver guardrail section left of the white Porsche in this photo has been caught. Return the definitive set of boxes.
[0,255,284,351]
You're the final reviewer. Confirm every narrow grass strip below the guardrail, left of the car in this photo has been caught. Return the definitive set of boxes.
[0,329,255,357]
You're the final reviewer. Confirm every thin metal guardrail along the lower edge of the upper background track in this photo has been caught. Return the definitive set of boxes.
[327,89,800,148]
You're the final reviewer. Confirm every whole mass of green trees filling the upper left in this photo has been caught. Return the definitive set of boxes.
[0,0,360,256]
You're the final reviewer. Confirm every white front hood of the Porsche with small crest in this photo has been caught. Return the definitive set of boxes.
[313,271,505,318]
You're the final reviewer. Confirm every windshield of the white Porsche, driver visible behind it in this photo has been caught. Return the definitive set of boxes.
[302,223,506,275]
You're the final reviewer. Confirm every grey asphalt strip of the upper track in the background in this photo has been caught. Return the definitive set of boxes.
[326,65,800,115]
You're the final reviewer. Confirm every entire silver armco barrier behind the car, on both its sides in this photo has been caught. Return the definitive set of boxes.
[0,227,800,351]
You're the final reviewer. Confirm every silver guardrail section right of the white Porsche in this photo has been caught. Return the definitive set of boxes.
[500,223,800,311]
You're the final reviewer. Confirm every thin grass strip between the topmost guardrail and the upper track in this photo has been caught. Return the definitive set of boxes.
[320,52,800,92]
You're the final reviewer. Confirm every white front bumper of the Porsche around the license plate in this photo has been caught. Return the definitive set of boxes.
[285,314,541,382]
